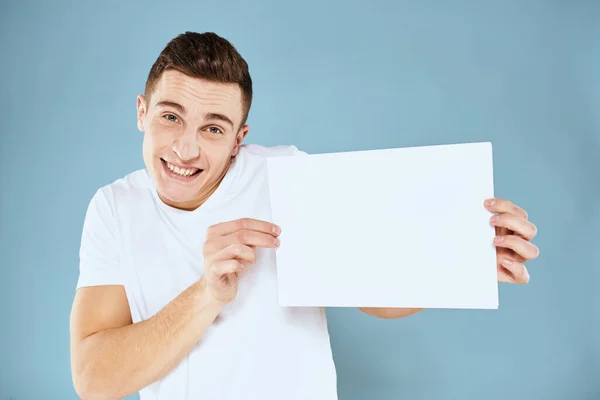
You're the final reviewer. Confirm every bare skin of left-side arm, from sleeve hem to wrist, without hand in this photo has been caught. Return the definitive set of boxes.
[71,280,222,400]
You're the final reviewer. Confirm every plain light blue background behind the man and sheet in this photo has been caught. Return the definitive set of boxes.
[0,0,600,400]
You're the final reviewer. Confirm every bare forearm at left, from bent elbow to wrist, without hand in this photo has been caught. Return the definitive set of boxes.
[74,282,221,400]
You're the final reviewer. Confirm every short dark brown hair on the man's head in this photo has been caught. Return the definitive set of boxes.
[145,32,252,125]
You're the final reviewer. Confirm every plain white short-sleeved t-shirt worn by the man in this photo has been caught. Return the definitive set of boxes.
[77,145,337,400]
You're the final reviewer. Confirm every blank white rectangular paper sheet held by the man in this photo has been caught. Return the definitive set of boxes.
[267,142,498,309]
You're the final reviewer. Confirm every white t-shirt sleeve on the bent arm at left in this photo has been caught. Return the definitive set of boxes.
[77,189,123,289]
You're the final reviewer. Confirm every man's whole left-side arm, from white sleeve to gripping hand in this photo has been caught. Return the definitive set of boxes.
[71,191,279,400]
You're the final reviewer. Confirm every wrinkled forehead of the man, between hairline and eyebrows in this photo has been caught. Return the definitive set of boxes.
[151,70,242,121]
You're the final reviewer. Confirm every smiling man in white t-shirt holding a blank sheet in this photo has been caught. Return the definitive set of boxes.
[71,33,538,400]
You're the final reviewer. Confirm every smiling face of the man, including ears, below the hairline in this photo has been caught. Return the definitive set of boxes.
[137,70,249,210]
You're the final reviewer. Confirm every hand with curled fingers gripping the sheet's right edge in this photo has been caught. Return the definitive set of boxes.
[485,198,540,283]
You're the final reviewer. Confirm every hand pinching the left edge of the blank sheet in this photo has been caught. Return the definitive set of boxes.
[201,218,281,305]
